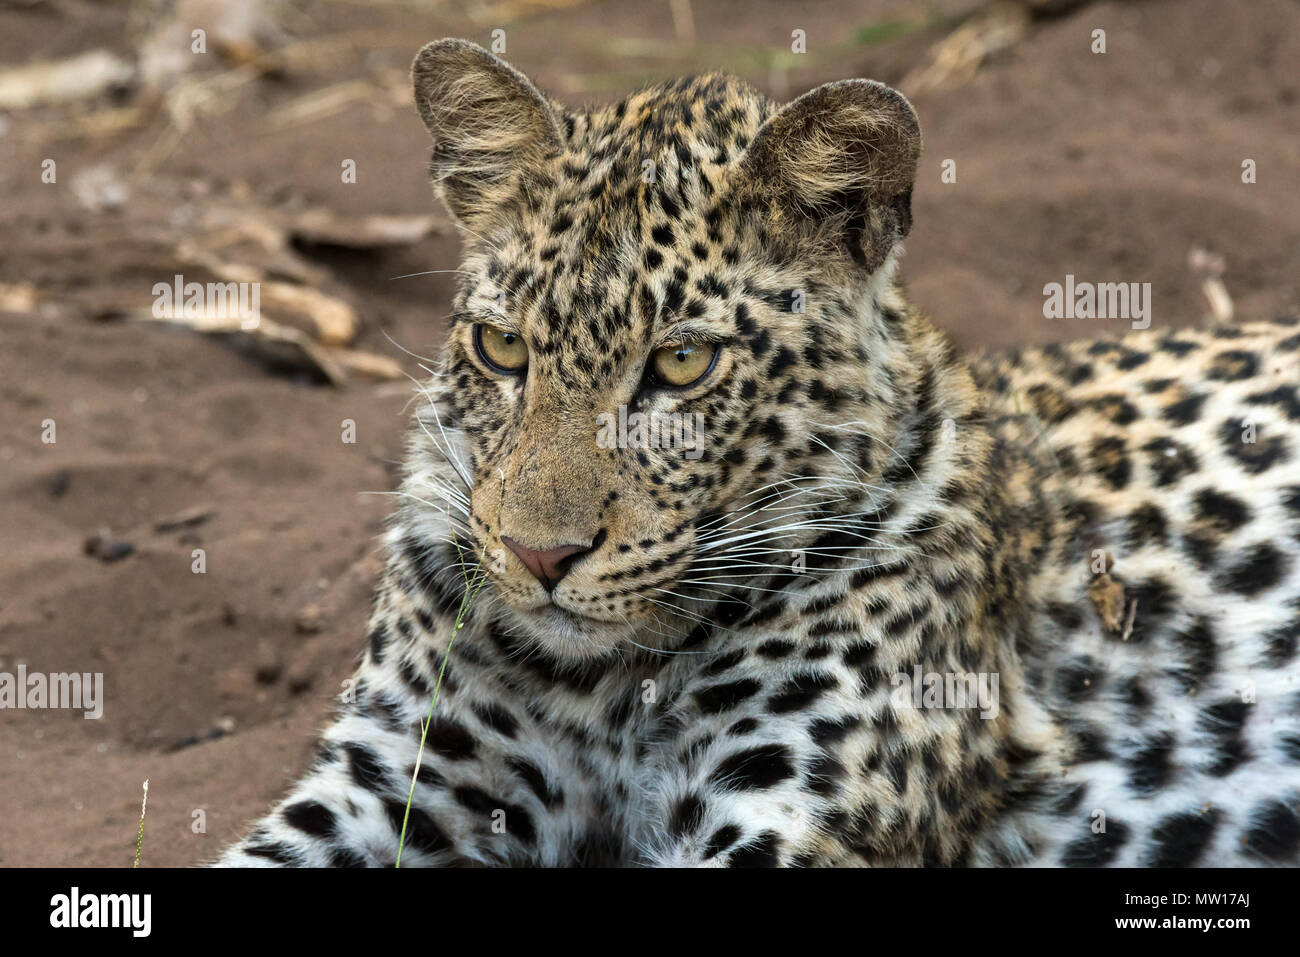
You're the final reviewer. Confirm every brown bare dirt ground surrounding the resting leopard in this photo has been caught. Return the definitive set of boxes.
[0,0,1300,867]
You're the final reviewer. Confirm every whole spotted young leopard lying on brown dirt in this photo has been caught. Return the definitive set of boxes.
[216,39,1300,867]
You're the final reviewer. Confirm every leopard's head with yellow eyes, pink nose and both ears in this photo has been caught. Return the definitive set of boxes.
[406,40,920,659]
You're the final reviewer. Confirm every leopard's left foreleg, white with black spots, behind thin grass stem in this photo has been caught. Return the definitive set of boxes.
[218,597,584,866]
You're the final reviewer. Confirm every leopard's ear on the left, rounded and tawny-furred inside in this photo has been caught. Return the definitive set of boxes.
[411,39,563,228]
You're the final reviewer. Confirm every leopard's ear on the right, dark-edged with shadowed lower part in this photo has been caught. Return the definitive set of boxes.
[737,79,920,272]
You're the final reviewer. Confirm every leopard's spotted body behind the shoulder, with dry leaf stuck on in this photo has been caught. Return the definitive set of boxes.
[975,320,1300,866]
